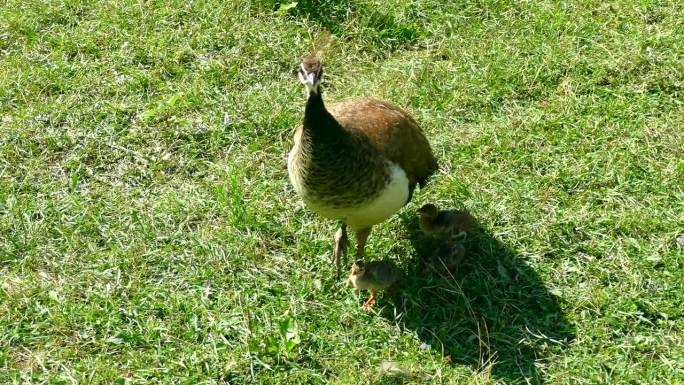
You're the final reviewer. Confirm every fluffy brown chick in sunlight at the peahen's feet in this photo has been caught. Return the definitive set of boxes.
[349,260,399,308]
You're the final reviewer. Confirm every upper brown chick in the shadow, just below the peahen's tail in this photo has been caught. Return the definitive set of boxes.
[418,203,477,240]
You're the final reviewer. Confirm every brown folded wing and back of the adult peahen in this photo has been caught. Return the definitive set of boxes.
[327,99,437,187]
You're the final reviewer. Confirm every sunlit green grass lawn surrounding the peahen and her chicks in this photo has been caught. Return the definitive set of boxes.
[0,0,684,384]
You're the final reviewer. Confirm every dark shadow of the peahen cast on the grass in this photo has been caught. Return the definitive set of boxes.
[382,213,575,384]
